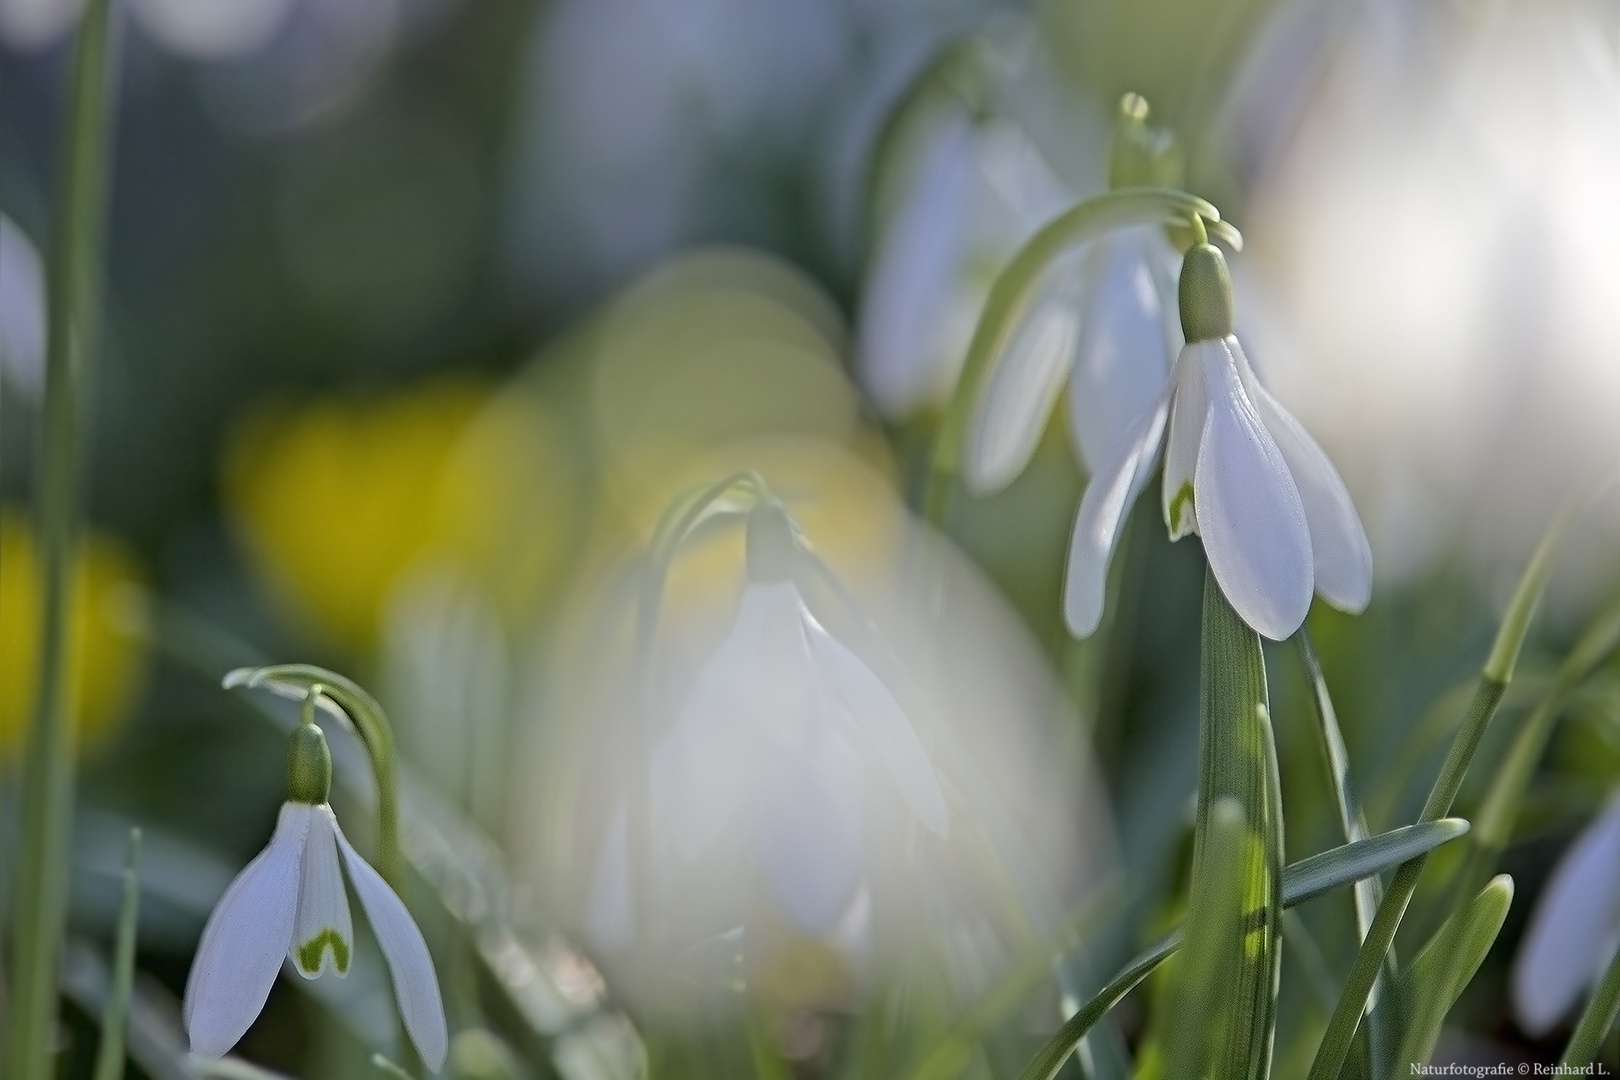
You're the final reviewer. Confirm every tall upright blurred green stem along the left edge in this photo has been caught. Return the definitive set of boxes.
[8,0,110,1080]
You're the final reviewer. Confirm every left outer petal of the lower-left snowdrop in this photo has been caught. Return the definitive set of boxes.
[181,803,314,1057]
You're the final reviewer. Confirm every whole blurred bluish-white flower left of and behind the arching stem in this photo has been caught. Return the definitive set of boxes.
[855,112,1071,418]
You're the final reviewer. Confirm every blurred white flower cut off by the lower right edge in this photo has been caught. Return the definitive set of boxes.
[1511,795,1620,1038]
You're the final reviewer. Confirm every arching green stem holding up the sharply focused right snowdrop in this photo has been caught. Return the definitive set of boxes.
[922,188,1243,529]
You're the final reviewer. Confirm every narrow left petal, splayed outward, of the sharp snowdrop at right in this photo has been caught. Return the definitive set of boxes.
[1063,395,1170,638]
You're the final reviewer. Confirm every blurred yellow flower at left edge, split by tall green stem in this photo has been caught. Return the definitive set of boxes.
[0,508,144,764]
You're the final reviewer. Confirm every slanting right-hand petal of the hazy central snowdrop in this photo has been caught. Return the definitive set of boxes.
[802,610,949,836]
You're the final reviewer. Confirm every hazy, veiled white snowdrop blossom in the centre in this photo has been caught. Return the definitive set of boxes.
[591,505,948,946]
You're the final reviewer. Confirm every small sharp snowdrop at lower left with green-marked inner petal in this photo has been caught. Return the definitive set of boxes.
[181,722,449,1072]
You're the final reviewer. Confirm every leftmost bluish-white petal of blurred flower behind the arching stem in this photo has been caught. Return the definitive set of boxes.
[857,117,977,416]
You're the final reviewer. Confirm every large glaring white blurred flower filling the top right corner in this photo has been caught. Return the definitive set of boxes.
[1221,0,1620,591]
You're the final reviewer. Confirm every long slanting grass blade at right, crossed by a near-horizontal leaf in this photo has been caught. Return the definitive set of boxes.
[1309,491,1589,1080]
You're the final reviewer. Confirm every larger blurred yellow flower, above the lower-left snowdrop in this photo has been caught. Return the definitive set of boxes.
[224,379,564,649]
